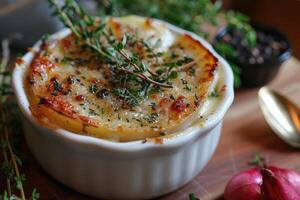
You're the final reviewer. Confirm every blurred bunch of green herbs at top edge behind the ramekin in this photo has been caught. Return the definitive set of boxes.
[96,0,222,36]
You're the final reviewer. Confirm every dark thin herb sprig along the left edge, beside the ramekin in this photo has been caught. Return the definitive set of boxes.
[0,36,39,200]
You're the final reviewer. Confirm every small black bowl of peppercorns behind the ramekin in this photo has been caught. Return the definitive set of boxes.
[215,25,292,87]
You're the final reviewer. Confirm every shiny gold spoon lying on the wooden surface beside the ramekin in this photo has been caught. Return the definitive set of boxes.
[258,87,300,148]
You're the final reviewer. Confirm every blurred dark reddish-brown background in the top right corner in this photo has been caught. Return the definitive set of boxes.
[225,0,300,58]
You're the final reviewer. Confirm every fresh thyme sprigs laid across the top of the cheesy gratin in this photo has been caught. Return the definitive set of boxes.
[48,0,176,106]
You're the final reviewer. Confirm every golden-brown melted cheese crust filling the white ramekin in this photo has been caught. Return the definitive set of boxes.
[26,16,217,142]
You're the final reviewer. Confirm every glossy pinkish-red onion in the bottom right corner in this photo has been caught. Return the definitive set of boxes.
[224,166,300,200]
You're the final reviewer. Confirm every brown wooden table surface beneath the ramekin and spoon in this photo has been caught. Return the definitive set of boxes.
[0,58,300,200]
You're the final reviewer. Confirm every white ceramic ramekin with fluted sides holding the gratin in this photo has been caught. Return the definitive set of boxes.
[13,20,234,199]
